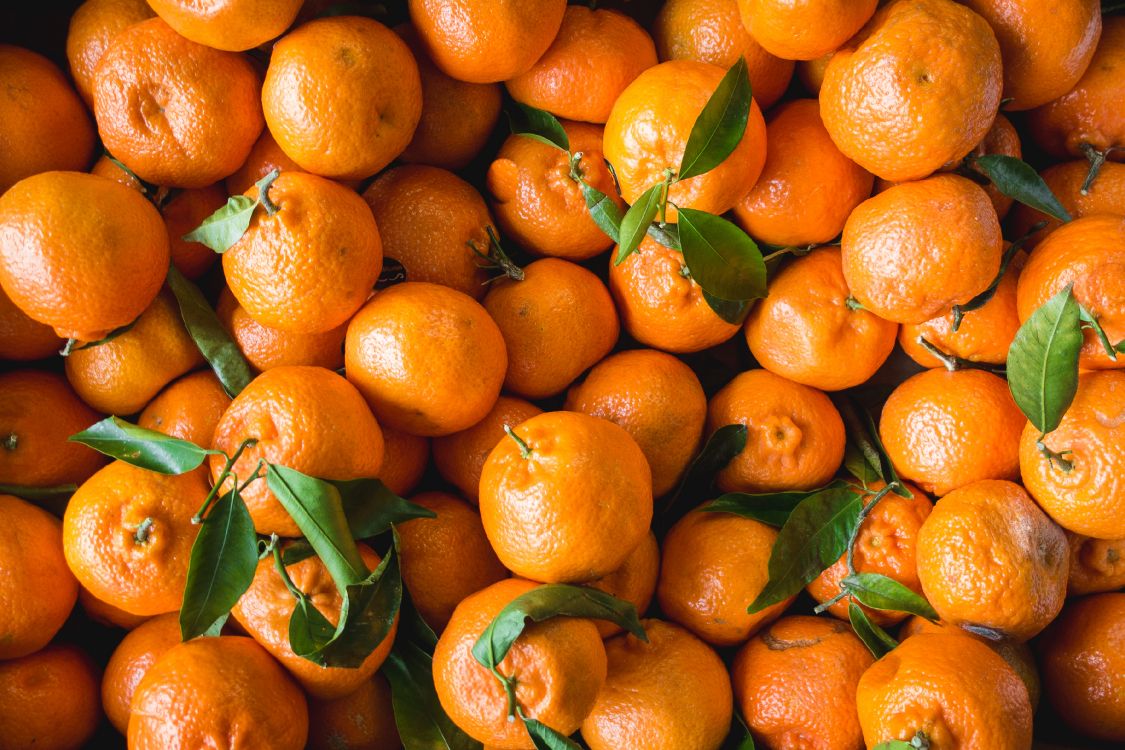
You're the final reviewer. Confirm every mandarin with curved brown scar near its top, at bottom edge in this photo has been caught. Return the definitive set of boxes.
[731,615,875,750]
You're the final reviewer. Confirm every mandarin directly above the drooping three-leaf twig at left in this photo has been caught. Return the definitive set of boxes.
[209,367,384,536]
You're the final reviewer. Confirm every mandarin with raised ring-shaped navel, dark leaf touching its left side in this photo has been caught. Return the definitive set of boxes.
[707,370,844,493]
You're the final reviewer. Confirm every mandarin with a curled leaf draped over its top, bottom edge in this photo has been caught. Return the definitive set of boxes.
[433,578,606,750]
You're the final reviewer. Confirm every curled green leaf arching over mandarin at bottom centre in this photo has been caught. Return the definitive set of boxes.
[473,584,648,669]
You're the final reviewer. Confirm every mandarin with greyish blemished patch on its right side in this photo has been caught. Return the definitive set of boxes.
[917,480,1070,641]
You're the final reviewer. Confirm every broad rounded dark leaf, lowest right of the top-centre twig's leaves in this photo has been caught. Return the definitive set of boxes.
[677,208,766,300]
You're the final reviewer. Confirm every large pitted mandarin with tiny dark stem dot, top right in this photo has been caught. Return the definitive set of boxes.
[820,0,1004,182]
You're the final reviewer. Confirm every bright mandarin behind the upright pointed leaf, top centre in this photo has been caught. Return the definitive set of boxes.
[603,60,766,222]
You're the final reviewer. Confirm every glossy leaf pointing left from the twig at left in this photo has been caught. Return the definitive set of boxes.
[68,416,222,475]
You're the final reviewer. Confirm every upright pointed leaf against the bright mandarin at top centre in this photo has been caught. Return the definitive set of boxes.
[676,57,752,180]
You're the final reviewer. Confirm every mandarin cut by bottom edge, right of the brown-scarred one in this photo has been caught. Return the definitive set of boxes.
[856,633,1032,750]
